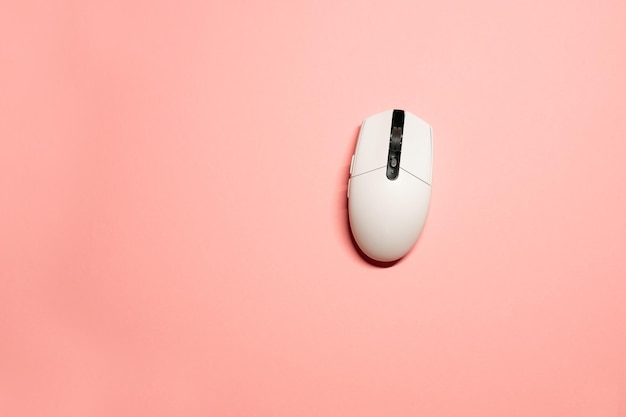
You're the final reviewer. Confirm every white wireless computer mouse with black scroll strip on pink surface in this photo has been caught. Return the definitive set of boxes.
[348,110,433,262]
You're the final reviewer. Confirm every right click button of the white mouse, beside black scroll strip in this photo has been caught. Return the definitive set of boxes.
[400,112,433,184]
